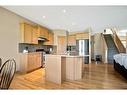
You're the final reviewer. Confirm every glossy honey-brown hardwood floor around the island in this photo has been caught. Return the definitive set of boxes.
[10,63,127,89]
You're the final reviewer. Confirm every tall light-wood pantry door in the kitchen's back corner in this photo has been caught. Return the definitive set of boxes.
[58,36,67,54]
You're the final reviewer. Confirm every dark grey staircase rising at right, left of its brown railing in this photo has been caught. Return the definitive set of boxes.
[104,34,119,63]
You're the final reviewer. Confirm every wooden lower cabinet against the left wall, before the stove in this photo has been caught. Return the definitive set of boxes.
[20,52,42,73]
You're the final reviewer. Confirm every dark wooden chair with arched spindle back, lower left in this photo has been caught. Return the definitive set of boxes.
[0,59,16,89]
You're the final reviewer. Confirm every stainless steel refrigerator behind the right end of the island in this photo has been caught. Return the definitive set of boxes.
[76,39,89,63]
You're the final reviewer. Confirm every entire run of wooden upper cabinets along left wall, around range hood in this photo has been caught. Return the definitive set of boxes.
[20,23,54,45]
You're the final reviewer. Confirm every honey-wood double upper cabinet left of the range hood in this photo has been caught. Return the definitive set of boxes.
[20,23,38,44]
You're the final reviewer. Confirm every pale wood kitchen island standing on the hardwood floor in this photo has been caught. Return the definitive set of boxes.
[45,55,83,84]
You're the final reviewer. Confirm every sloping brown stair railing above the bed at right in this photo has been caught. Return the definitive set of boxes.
[111,29,126,53]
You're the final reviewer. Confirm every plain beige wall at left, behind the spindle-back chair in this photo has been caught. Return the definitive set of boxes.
[0,7,36,70]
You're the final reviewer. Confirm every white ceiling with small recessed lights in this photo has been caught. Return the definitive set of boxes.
[4,6,127,32]
